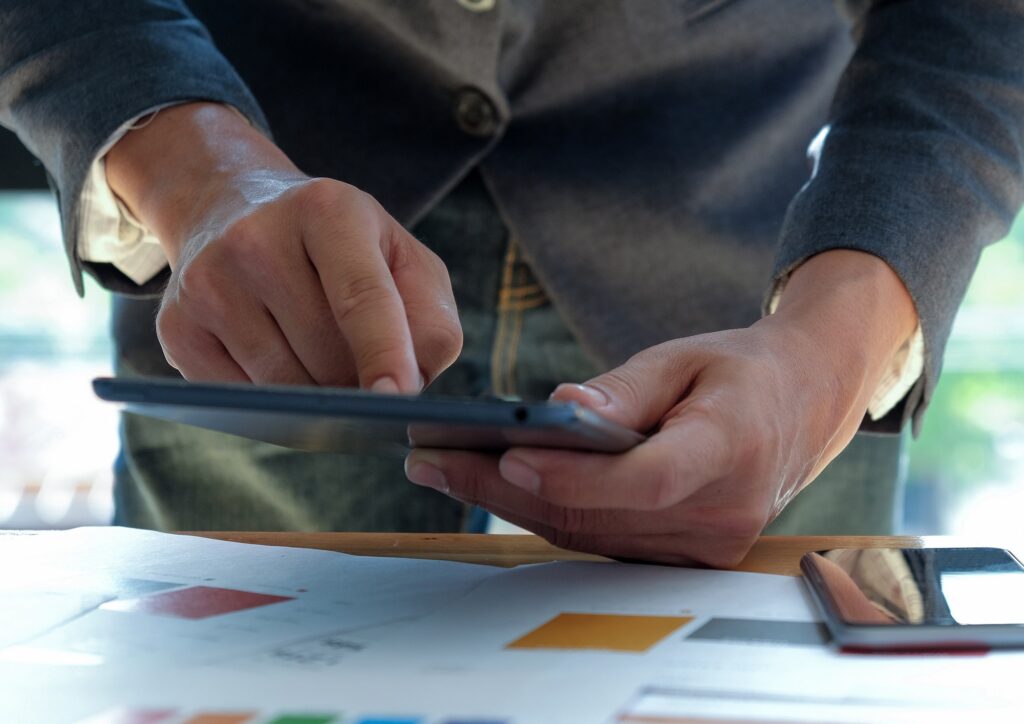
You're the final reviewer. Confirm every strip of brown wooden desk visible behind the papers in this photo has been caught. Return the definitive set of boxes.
[188,531,1007,576]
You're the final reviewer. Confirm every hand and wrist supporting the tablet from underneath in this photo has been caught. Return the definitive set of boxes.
[407,251,916,567]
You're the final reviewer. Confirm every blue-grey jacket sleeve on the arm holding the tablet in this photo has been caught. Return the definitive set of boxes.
[774,0,1024,432]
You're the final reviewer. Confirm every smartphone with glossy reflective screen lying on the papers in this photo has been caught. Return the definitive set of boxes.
[800,548,1024,651]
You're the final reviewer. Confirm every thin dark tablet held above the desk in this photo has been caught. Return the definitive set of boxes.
[92,378,644,456]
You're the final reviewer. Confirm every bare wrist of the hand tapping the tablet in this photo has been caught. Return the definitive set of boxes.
[105,102,302,266]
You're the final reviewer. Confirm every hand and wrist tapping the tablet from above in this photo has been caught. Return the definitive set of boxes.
[106,103,462,392]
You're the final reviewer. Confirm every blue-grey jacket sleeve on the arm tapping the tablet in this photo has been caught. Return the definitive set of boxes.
[0,0,266,294]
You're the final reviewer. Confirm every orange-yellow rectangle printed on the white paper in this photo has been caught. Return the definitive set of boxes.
[506,613,693,653]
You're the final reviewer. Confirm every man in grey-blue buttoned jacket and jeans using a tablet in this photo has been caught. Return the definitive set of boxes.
[0,0,1024,565]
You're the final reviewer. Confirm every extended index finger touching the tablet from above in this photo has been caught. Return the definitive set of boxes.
[304,206,420,393]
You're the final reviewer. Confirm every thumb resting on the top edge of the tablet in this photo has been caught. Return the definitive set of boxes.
[551,341,699,432]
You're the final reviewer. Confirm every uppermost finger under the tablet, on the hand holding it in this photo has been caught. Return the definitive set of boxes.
[499,411,732,510]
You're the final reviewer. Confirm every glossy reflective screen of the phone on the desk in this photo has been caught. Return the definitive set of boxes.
[803,548,1024,627]
